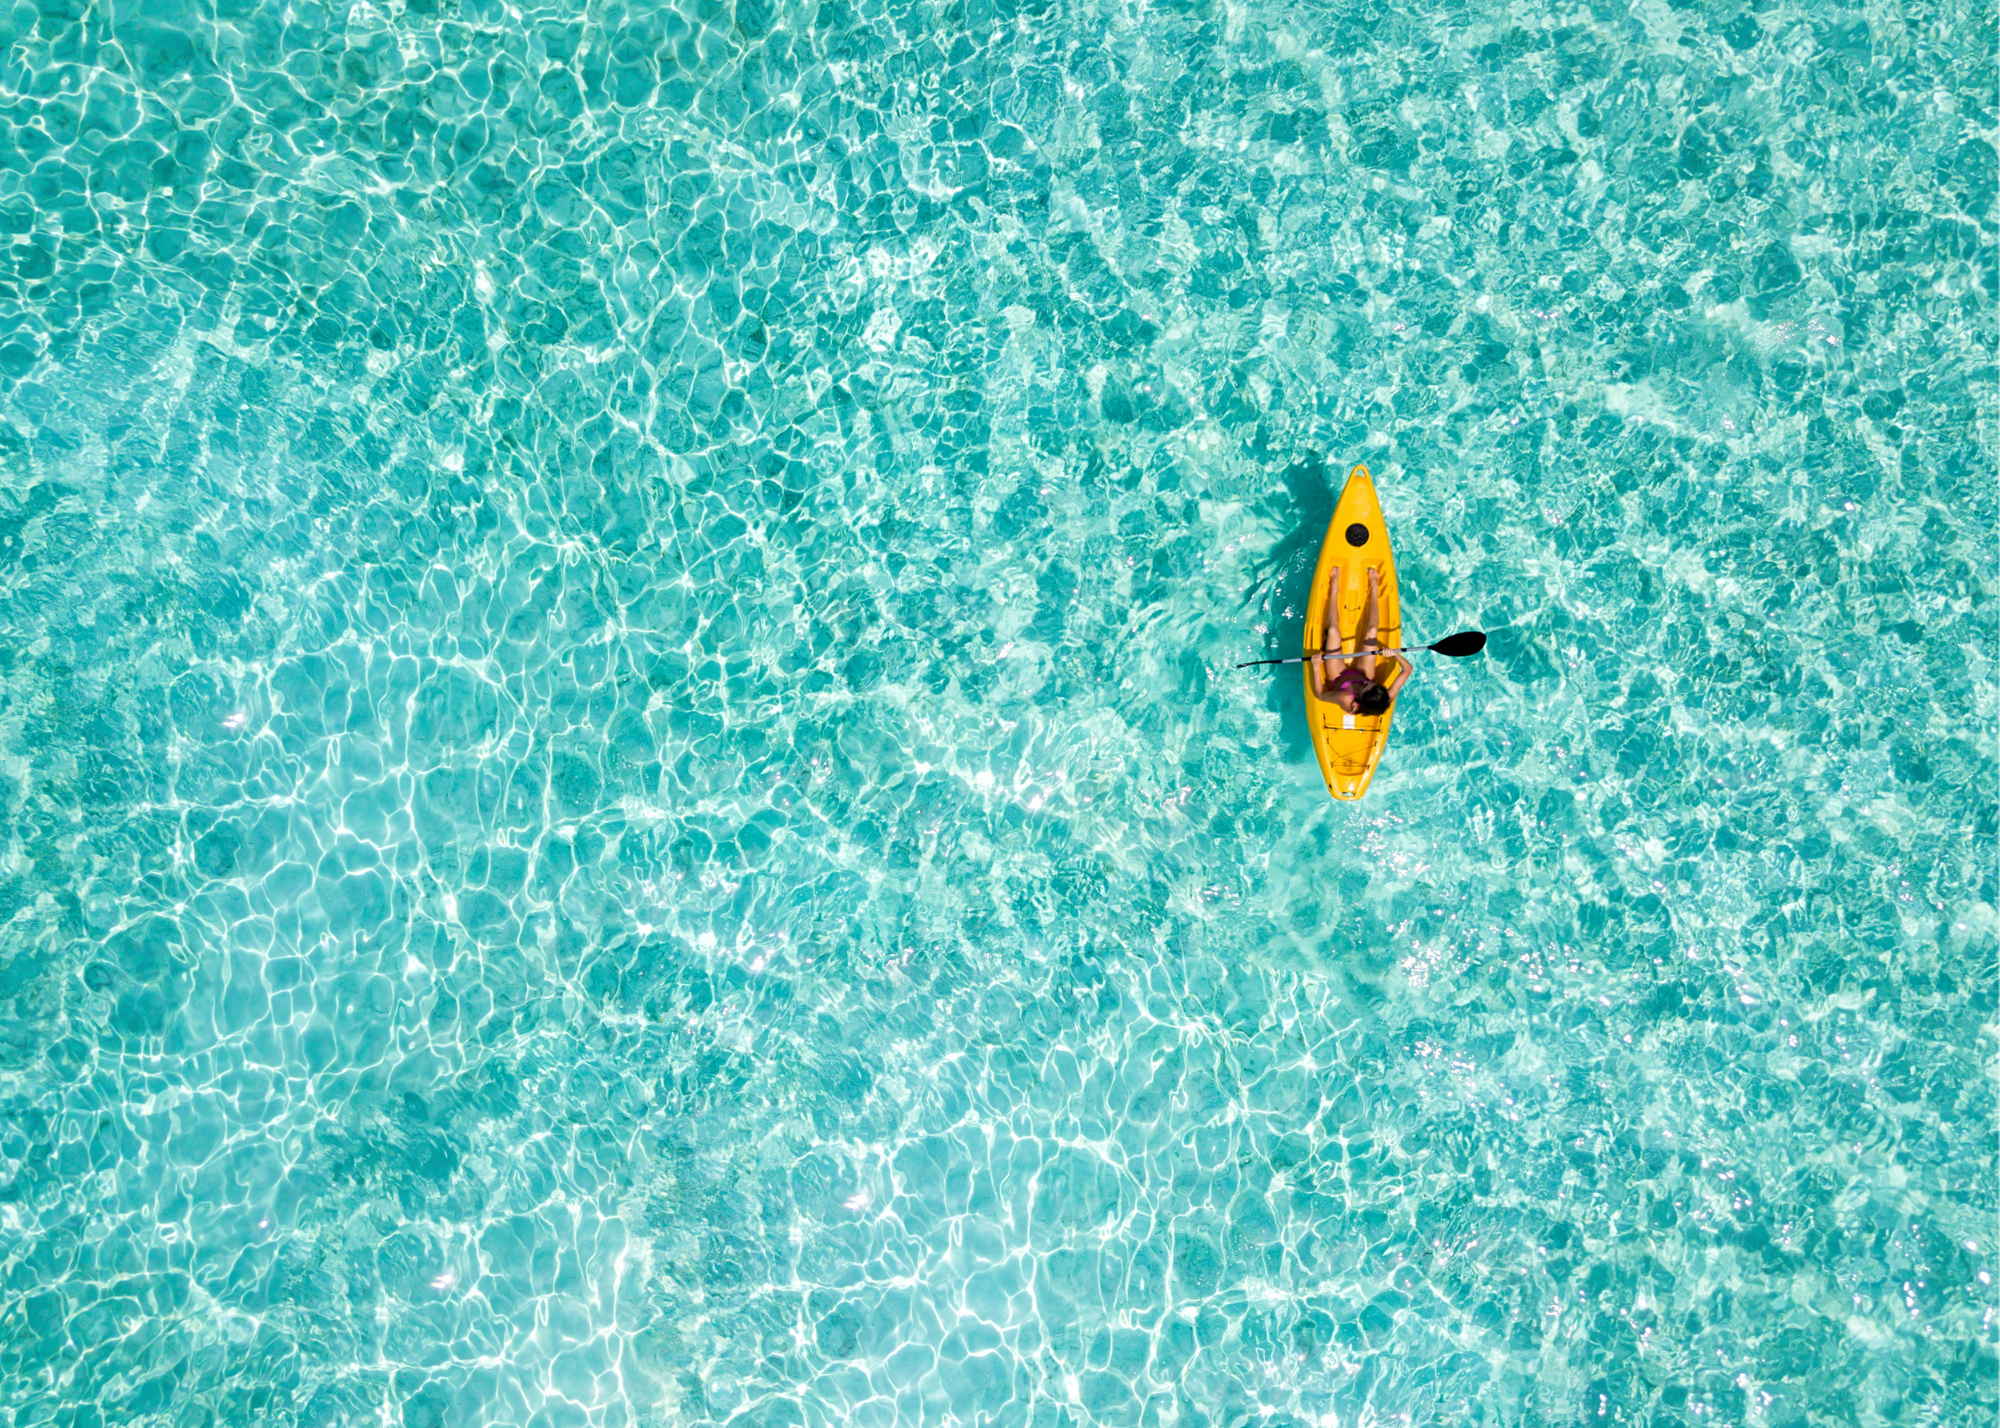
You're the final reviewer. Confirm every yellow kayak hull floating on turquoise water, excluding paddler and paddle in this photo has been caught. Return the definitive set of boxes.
[1306,466,1402,800]
